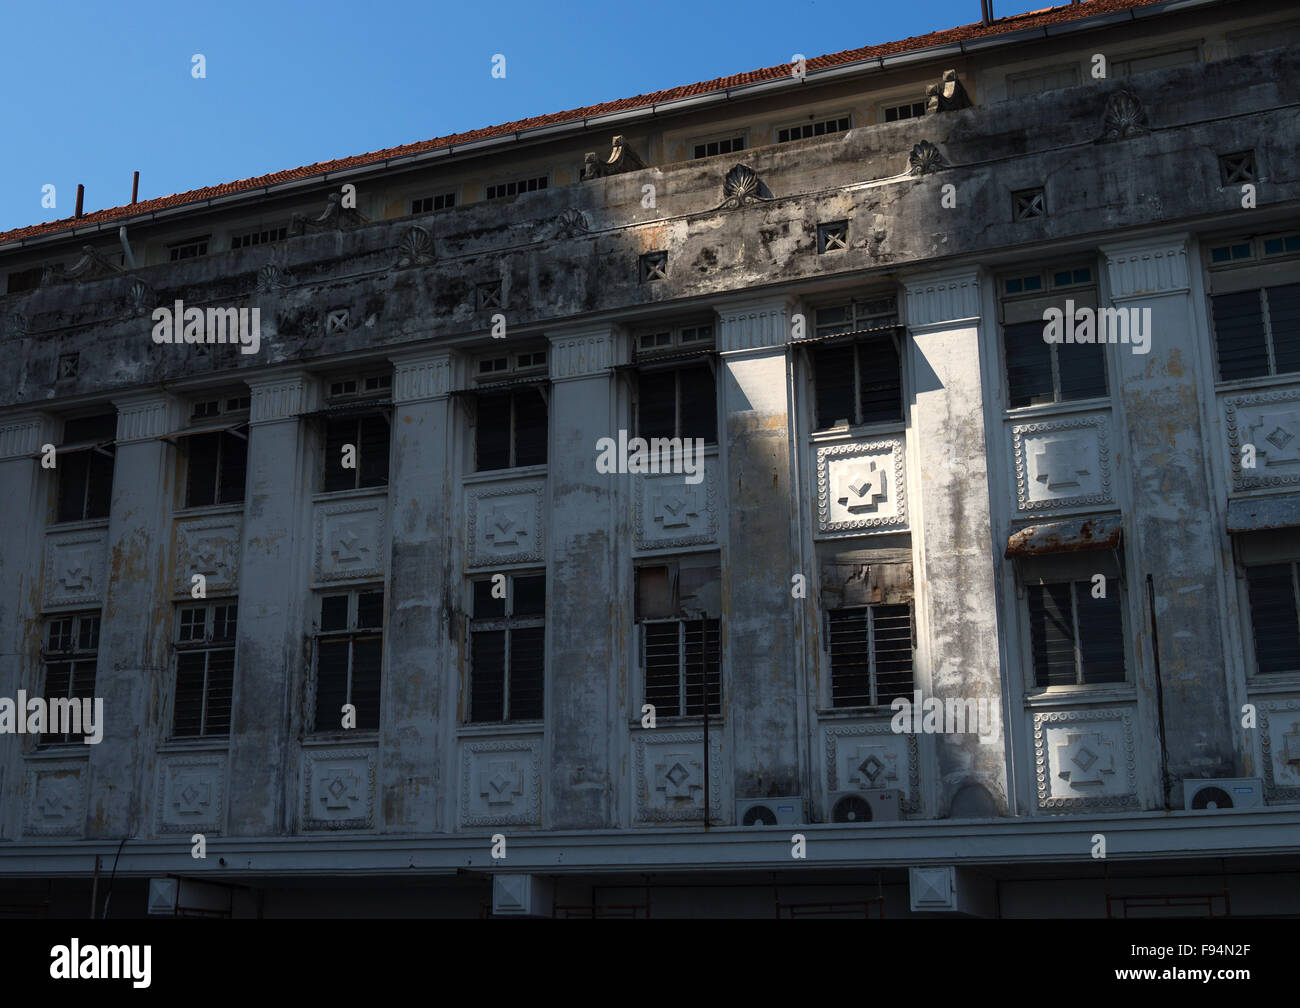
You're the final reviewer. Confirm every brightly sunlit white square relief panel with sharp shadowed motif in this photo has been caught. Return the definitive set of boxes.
[816,438,907,532]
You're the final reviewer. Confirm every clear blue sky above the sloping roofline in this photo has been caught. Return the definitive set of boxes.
[0,0,1052,230]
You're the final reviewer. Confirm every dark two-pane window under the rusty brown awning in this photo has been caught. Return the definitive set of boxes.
[1026,577,1125,687]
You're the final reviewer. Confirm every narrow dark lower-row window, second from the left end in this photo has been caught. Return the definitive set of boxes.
[172,598,238,739]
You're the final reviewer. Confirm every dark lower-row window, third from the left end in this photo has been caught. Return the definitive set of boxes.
[313,588,384,731]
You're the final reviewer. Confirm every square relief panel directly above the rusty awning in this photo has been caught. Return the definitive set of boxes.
[1011,414,1114,511]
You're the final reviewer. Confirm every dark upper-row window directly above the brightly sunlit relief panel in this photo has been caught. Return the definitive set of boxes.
[811,297,902,431]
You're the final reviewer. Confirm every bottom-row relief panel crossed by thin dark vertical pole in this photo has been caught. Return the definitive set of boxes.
[632,724,729,825]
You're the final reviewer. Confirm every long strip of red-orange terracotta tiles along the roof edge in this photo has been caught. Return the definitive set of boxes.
[0,0,1160,245]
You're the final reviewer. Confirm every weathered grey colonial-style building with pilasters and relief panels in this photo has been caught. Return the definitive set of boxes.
[0,0,1300,917]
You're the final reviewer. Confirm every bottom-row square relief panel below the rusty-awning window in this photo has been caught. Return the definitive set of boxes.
[1034,709,1138,810]
